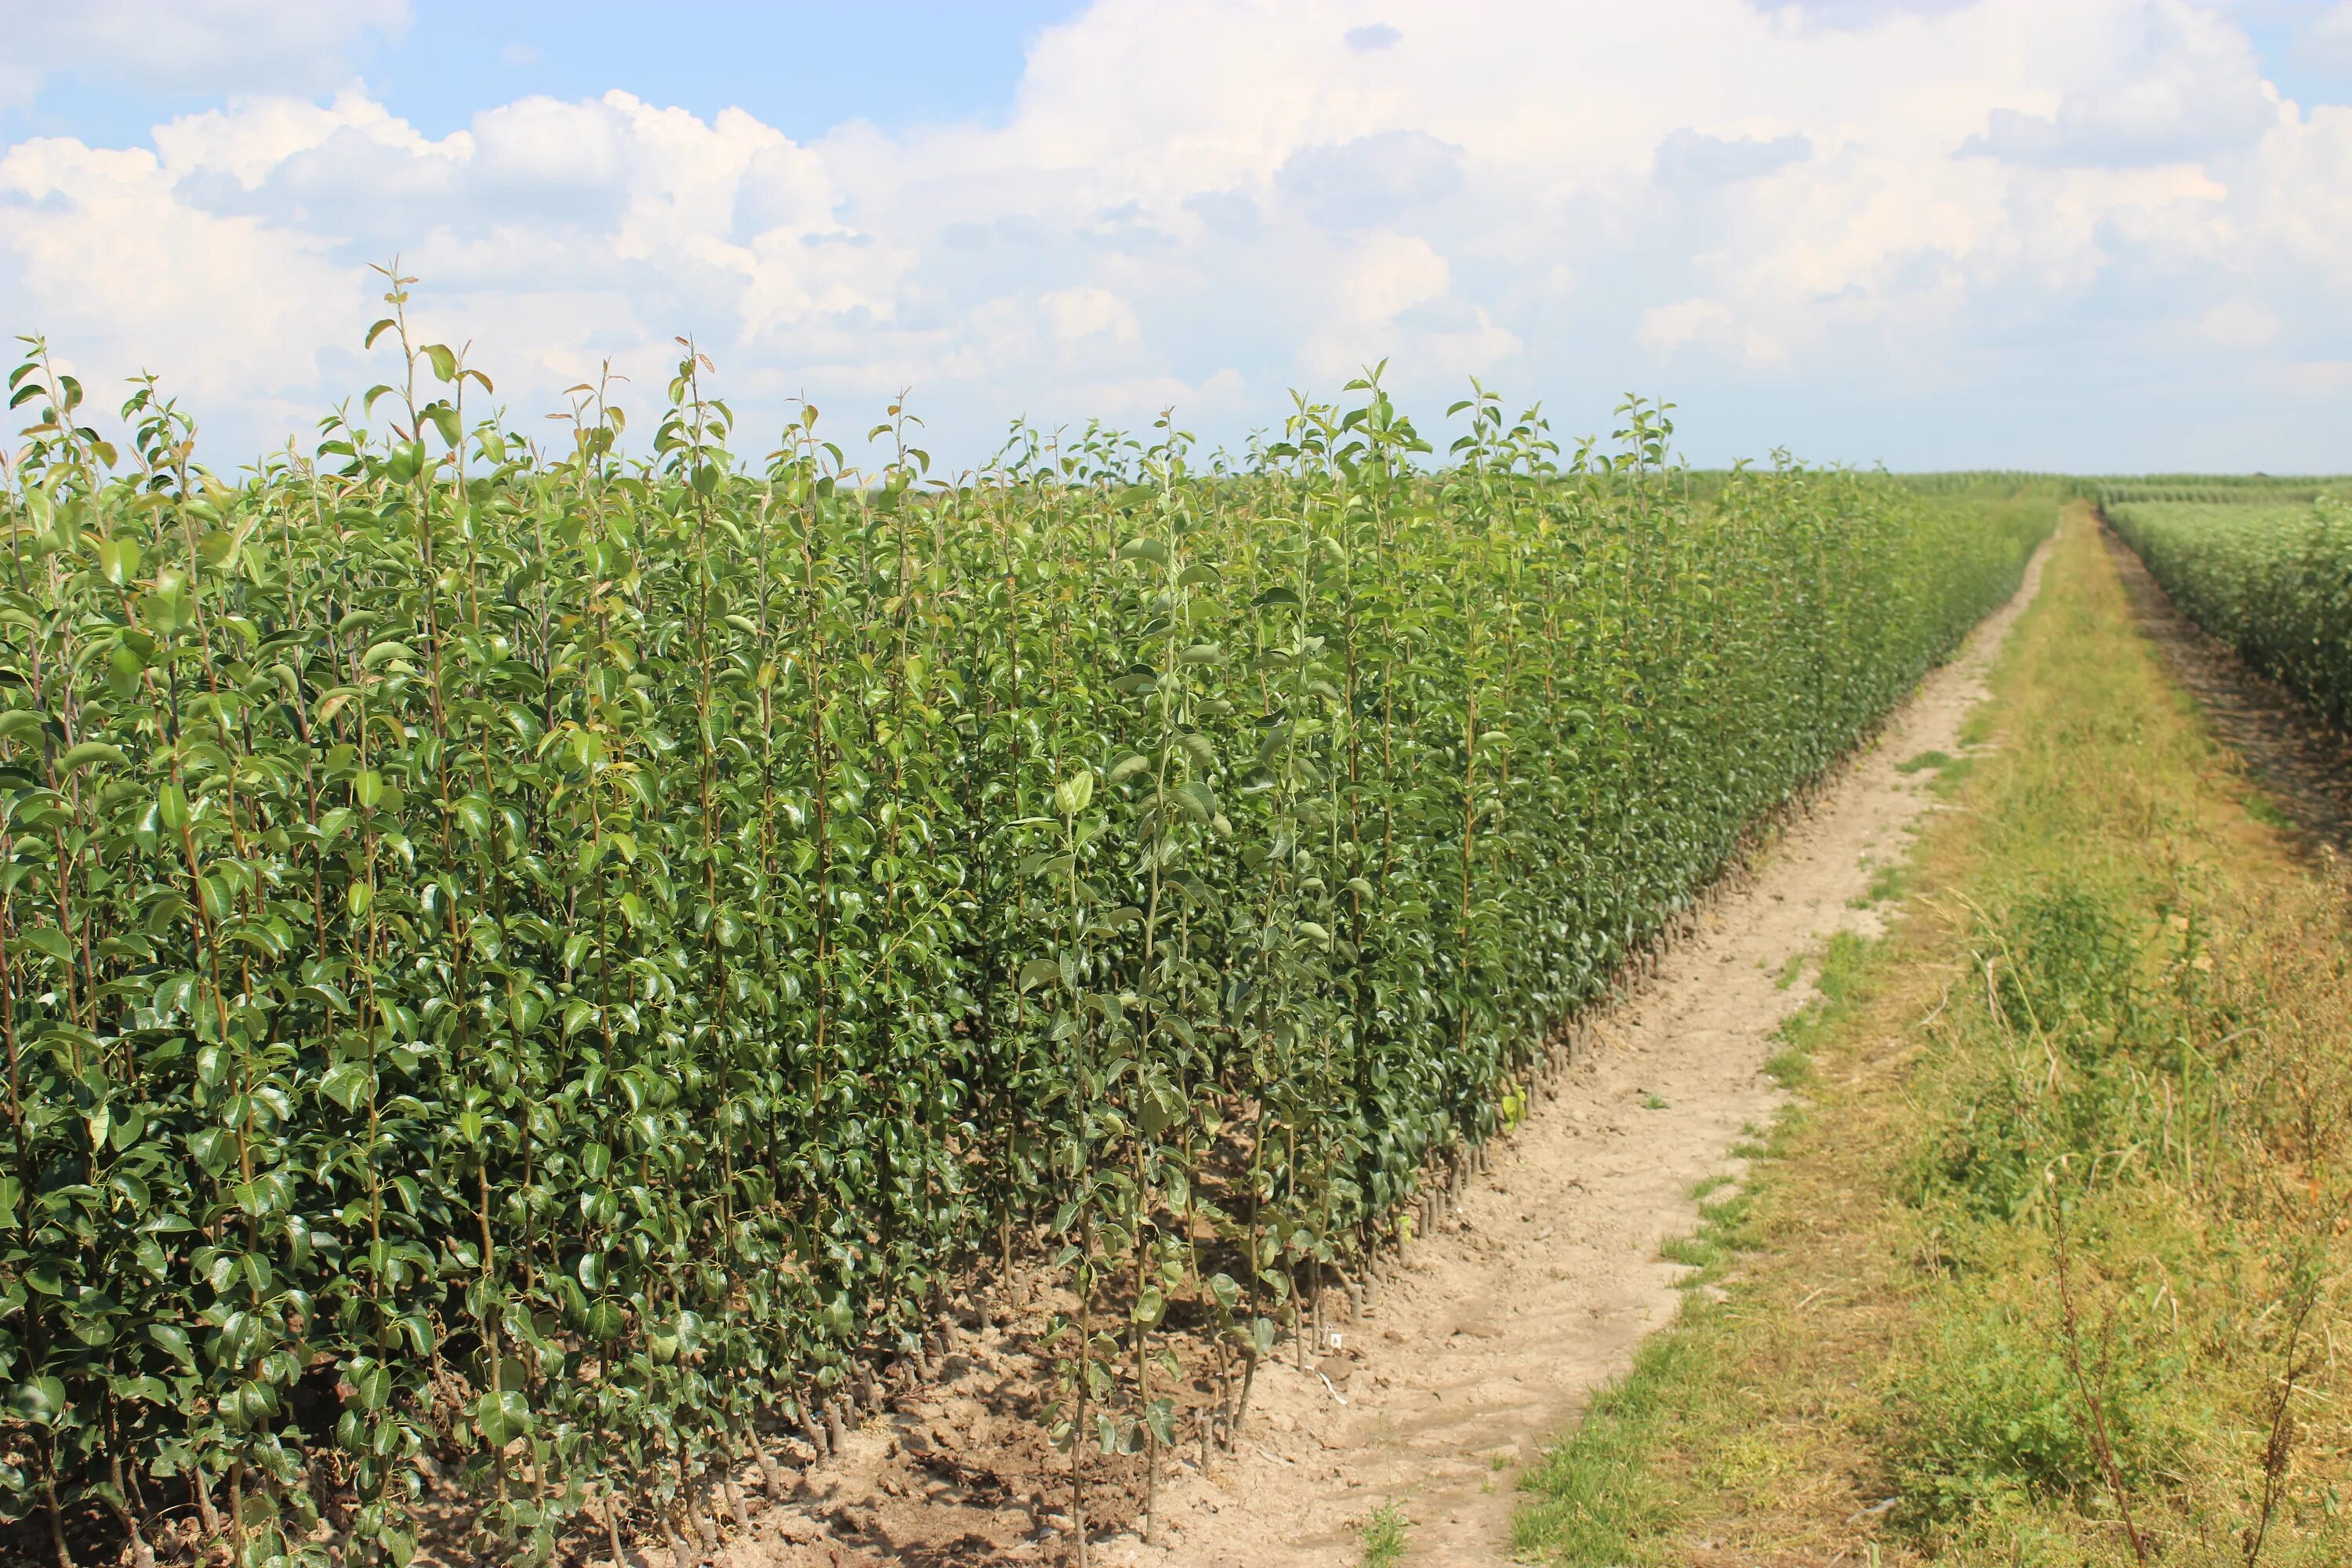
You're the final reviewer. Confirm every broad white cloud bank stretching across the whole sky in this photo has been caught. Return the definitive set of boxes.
[0,0,2352,461]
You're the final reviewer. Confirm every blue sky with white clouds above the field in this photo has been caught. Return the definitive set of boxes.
[0,0,2352,473]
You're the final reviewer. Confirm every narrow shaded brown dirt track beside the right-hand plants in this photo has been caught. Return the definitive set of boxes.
[2103,529,2352,853]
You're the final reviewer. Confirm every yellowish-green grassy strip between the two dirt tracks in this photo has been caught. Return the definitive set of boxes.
[1517,513,2352,1568]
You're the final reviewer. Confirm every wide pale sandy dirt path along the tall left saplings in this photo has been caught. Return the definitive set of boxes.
[1096,531,2042,1568]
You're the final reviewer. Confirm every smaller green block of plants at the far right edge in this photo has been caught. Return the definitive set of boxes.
[2105,496,2352,729]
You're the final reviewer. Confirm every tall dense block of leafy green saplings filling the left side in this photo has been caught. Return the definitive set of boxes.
[0,287,2044,1563]
